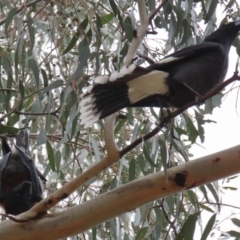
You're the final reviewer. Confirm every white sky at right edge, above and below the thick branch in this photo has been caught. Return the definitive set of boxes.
[190,47,240,240]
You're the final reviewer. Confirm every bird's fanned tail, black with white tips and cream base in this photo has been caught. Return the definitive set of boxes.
[80,65,169,127]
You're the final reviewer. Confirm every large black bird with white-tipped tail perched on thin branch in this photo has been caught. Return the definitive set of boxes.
[80,20,240,127]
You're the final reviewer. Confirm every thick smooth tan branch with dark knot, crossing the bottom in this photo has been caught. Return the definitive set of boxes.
[0,145,240,240]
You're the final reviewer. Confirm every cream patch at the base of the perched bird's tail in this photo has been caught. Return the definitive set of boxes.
[127,71,169,104]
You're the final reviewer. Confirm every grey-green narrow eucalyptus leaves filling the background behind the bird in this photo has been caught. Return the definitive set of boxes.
[0,0,240,240]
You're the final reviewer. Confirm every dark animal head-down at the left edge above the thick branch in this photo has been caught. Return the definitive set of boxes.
[0,129,46,215]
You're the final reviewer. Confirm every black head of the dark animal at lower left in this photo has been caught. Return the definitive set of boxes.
[2,181,35,215]
